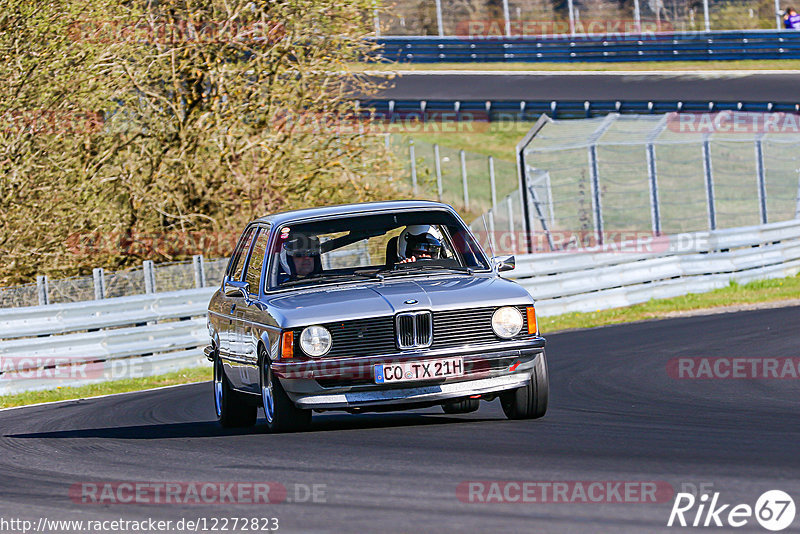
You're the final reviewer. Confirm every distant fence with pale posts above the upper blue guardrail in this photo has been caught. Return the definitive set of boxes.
[373,0,787,37]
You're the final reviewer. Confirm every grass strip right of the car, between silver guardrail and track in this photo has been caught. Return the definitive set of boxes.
[539,275,800,335]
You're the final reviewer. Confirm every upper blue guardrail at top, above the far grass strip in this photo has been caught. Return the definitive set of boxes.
[374,30,800,63]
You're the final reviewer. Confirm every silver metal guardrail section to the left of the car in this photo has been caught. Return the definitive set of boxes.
[0,287,217,395]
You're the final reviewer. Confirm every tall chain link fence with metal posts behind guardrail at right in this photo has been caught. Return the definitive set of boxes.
[504,112,800,249]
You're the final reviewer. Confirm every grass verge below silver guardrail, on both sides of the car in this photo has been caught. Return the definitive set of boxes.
[0,275,800,408]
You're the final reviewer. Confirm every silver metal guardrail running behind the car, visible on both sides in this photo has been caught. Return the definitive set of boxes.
[0,221,800,394]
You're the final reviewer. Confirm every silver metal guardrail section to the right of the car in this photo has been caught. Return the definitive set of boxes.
[508,221,800,316]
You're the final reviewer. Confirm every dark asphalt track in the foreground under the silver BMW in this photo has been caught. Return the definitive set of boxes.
[0,307,800,534]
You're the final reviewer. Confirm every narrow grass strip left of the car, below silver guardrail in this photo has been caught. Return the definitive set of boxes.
[0,367,212,408]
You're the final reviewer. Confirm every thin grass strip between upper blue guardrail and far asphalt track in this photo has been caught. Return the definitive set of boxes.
[348,59,800,72]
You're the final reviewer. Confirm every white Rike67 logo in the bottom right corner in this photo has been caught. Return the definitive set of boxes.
[667,490,795,532]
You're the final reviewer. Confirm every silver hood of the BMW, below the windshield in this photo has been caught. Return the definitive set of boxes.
[267,275,533,328]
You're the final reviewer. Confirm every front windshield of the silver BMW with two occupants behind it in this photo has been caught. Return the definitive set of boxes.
[269,210,489,290]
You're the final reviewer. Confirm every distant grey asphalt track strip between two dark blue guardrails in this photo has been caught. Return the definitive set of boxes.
[376,71,800,103]
